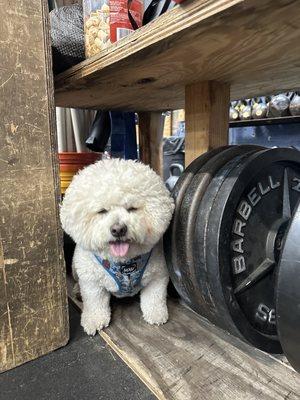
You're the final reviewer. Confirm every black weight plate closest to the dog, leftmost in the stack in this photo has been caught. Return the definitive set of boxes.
[164,146,230,303]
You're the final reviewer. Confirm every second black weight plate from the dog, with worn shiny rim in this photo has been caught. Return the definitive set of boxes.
[173,145,259,311]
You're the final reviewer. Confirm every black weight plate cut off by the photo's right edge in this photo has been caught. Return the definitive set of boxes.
[276,198,300,372]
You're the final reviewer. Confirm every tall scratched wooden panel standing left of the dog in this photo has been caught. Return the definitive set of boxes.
[0,0,69,371]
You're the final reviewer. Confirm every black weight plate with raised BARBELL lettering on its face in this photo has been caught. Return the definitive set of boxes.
[206,149,300,353]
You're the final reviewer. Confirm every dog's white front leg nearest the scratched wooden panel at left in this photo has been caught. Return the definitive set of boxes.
[79,279,110,335]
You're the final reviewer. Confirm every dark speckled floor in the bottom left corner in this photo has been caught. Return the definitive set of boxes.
[0,305,155,400]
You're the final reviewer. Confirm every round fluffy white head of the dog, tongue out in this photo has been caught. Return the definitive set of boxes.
[60,159,174,260]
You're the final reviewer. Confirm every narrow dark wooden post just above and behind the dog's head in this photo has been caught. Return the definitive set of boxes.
[139,112,164,176]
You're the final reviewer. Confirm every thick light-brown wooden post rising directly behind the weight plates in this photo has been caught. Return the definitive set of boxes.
[185,81,230,166]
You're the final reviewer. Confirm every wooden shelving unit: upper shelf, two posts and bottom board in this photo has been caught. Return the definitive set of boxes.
[55,0,300,400]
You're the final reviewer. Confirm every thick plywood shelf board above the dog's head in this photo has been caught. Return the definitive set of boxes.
[56,0,300,111]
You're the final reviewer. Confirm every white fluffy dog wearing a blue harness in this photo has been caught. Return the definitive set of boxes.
[60,159,174,335]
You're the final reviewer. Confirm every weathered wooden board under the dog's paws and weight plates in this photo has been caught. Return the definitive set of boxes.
[69,283,300,400]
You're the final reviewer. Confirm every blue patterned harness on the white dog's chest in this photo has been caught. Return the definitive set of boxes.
[94,251,152,297]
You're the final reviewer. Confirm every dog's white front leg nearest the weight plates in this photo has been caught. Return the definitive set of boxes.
[141,277,169,325]
